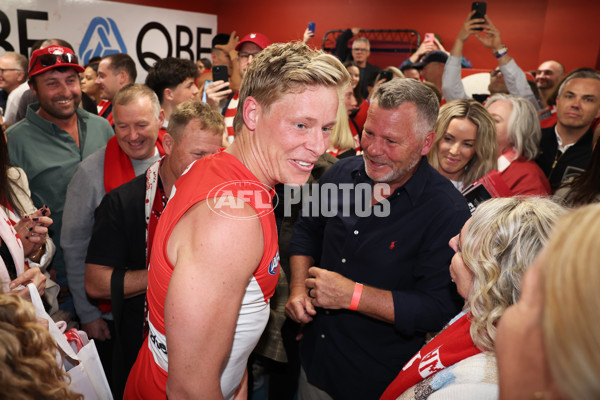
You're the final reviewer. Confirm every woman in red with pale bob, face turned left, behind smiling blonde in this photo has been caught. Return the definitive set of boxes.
[485,94,550,196]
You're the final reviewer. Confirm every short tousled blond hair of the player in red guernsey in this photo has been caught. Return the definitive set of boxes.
[233,42,350,134]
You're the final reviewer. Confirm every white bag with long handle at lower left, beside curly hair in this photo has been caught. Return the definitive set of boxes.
[27,283,113,400]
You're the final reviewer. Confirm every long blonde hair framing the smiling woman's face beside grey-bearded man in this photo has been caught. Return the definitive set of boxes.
[428,99,498,186]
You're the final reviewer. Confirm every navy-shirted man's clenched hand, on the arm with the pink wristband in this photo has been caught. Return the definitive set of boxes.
[306,267,356,310]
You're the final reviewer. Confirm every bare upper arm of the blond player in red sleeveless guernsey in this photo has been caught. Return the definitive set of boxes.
[165,202,263,399]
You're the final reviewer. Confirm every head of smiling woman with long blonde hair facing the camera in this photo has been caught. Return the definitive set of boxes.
[428,99,498,191]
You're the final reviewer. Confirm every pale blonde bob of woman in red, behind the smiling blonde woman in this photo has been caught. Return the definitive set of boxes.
[485,93,542,160]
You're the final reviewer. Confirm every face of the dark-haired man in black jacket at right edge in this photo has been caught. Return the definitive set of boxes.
[556,78,600,129]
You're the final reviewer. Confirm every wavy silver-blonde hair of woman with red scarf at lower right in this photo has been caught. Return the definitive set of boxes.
[462,197,566,351]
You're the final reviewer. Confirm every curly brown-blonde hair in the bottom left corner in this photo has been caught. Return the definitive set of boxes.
[0,293,83,400]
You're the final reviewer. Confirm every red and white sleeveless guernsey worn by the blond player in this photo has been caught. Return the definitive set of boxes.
[124,152,279,399]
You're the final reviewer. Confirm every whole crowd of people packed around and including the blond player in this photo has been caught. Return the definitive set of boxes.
[0,7,600,400]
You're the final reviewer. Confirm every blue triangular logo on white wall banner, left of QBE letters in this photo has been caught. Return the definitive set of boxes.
[79,17,127,65]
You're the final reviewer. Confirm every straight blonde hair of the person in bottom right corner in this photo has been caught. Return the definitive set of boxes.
[542,204,600,400]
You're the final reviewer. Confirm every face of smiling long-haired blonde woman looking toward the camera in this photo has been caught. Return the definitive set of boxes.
[438,118,477,181]
